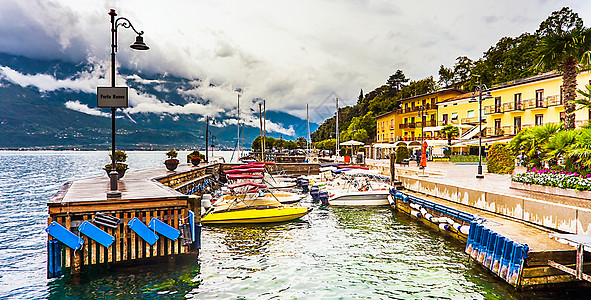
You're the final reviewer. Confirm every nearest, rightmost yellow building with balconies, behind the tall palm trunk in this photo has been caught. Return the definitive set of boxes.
[483,72,591,136]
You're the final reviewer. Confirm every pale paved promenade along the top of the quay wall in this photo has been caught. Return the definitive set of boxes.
[366,159,591,209]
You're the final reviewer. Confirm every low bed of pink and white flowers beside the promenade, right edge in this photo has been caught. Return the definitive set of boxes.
[511,168,591,191]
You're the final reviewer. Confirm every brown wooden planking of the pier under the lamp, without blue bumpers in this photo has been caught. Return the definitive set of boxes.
[47,163,211,273]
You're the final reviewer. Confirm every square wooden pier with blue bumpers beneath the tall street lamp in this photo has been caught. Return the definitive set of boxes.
[47,164,221,277]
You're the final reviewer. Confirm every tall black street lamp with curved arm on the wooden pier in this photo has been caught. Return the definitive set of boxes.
[107,9,150,198]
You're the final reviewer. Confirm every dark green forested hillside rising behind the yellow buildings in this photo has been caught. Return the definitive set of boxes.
[312,7,591,149]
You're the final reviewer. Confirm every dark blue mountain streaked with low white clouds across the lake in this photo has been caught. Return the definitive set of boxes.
[0,53,318,150]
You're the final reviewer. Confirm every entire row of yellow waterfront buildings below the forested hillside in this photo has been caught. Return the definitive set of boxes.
[376,71,591,158]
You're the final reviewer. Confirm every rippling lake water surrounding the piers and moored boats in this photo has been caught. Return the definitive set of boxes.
[0,151,587,299]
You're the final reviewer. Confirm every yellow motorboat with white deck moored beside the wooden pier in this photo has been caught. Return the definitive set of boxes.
[201,182,310,224]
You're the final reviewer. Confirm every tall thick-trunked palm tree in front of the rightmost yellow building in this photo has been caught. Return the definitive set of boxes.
[534,28,591,129]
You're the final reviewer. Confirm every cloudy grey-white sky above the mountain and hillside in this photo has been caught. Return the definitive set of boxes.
[0,0,591,122]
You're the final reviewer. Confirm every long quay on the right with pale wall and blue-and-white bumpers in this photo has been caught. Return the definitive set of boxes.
[386,168,591,288]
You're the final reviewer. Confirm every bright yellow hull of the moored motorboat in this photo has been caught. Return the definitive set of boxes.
[201,206,310,224]
